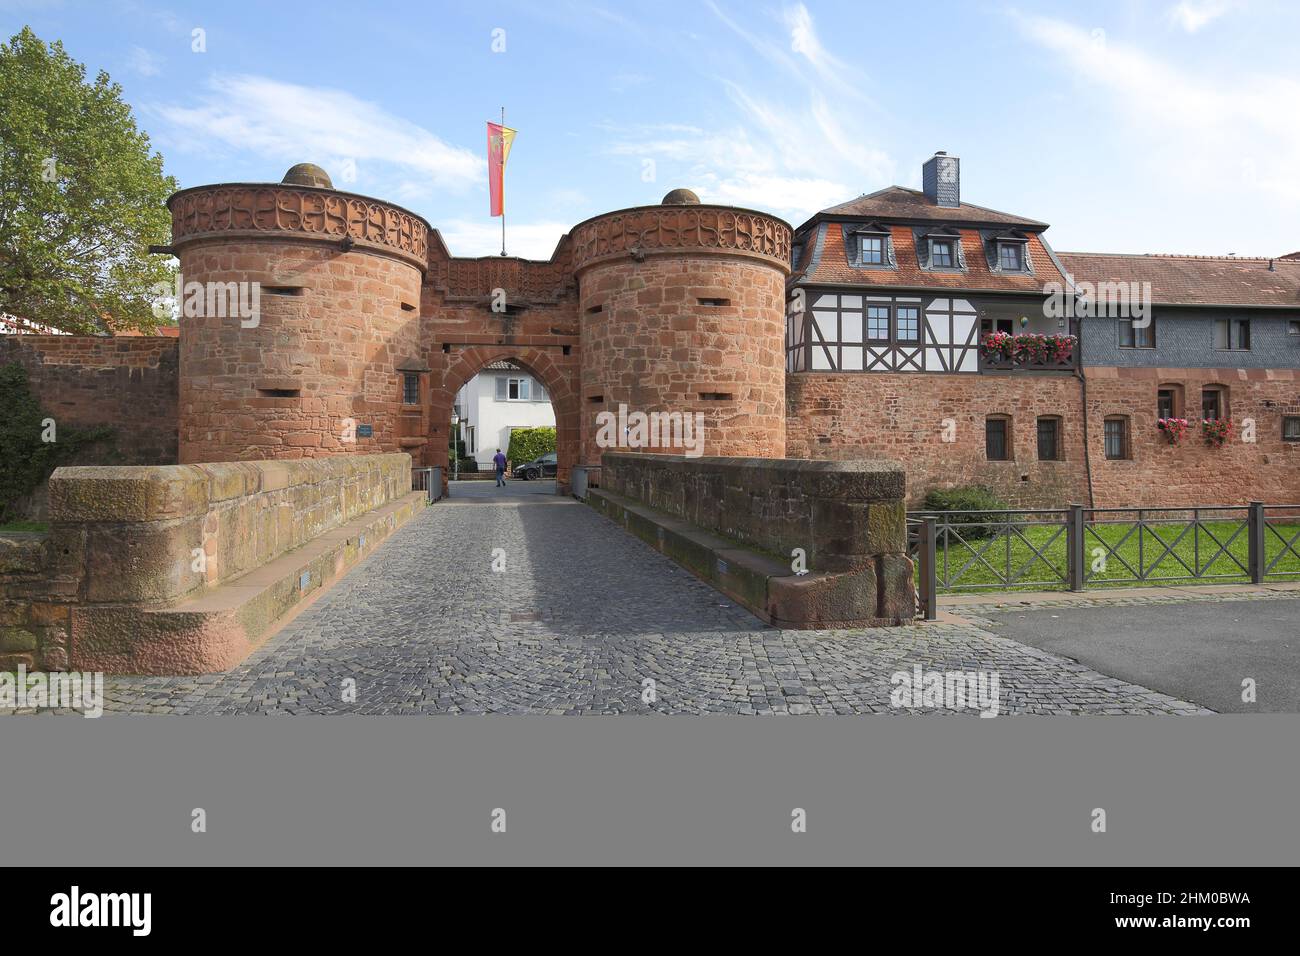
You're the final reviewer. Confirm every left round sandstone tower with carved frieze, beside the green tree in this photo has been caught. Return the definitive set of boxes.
[168,163,429,463]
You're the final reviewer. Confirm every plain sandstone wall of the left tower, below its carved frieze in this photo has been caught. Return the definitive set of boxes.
[179,239,423,463]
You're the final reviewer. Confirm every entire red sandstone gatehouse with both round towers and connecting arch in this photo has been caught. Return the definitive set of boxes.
[168,164,790,489]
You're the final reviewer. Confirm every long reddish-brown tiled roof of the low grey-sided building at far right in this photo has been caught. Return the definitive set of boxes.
[1057,252,1300,308]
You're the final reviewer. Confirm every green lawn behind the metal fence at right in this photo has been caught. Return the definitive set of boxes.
[920,519,1300,593]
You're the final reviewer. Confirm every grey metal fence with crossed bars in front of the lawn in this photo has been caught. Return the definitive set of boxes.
[907,502,1300,620]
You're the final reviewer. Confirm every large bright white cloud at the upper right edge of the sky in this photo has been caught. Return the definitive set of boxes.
[1018,17,1300,202]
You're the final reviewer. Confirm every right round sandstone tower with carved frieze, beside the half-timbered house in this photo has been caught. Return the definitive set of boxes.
[572,189,790,462]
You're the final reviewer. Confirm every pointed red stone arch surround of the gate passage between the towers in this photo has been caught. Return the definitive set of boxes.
[429,345,580,494]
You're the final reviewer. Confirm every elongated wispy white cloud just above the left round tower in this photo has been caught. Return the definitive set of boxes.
[152,75,486,202]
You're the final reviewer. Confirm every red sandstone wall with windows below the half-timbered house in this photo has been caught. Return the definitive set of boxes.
[787,368,1300,507]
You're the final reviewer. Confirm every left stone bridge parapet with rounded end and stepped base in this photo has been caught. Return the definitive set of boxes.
[0,454,425,674]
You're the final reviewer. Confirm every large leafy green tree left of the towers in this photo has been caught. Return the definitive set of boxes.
[0,27,176,334]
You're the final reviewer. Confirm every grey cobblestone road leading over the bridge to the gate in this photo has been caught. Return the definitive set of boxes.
[86,483,1203,714]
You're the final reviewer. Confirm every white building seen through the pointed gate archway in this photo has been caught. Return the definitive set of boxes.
[455,362,555,468]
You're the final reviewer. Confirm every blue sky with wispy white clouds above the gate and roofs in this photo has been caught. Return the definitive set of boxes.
[0,0,1300,258]
